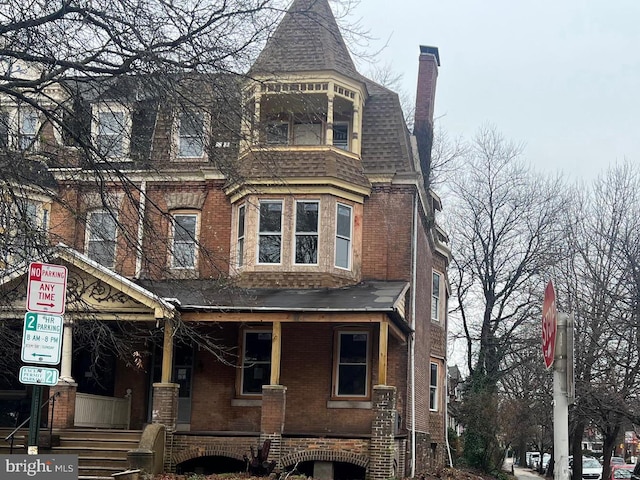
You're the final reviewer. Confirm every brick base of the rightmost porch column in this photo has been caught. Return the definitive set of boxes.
[367,385,396,480]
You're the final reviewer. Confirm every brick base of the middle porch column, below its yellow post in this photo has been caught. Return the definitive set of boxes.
[260,385,288,468]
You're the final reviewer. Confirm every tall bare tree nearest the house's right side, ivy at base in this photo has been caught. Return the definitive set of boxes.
[448,127,568,470]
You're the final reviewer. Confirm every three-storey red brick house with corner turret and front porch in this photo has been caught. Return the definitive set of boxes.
[2,0,449,480]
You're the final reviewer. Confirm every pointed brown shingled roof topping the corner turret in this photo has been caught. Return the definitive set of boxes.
[250,0,360,79]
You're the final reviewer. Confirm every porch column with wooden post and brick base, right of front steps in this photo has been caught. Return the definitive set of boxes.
[151,318,180,432]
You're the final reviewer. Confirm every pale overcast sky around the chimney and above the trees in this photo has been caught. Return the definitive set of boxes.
[352,0,640,180]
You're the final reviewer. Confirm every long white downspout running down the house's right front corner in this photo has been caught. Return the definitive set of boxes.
[409,194,418,478]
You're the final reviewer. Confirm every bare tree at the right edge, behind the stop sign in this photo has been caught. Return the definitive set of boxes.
[558,164,640,475]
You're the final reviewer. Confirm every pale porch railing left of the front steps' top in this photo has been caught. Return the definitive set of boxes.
[74,390,131,429]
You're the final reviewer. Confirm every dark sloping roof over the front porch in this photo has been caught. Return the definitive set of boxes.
[139,280,409,323]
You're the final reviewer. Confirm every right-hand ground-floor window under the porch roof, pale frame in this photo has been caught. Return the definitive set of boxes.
[333,331,370,398]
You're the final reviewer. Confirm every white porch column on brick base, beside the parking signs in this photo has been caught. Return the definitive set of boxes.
[47,319,78,428]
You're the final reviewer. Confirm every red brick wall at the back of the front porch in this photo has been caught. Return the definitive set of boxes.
[185,323,406,434]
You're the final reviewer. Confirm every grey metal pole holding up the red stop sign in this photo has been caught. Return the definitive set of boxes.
[553,313,569,480]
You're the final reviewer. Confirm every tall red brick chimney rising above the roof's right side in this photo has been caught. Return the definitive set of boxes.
[413,45,440,184]
